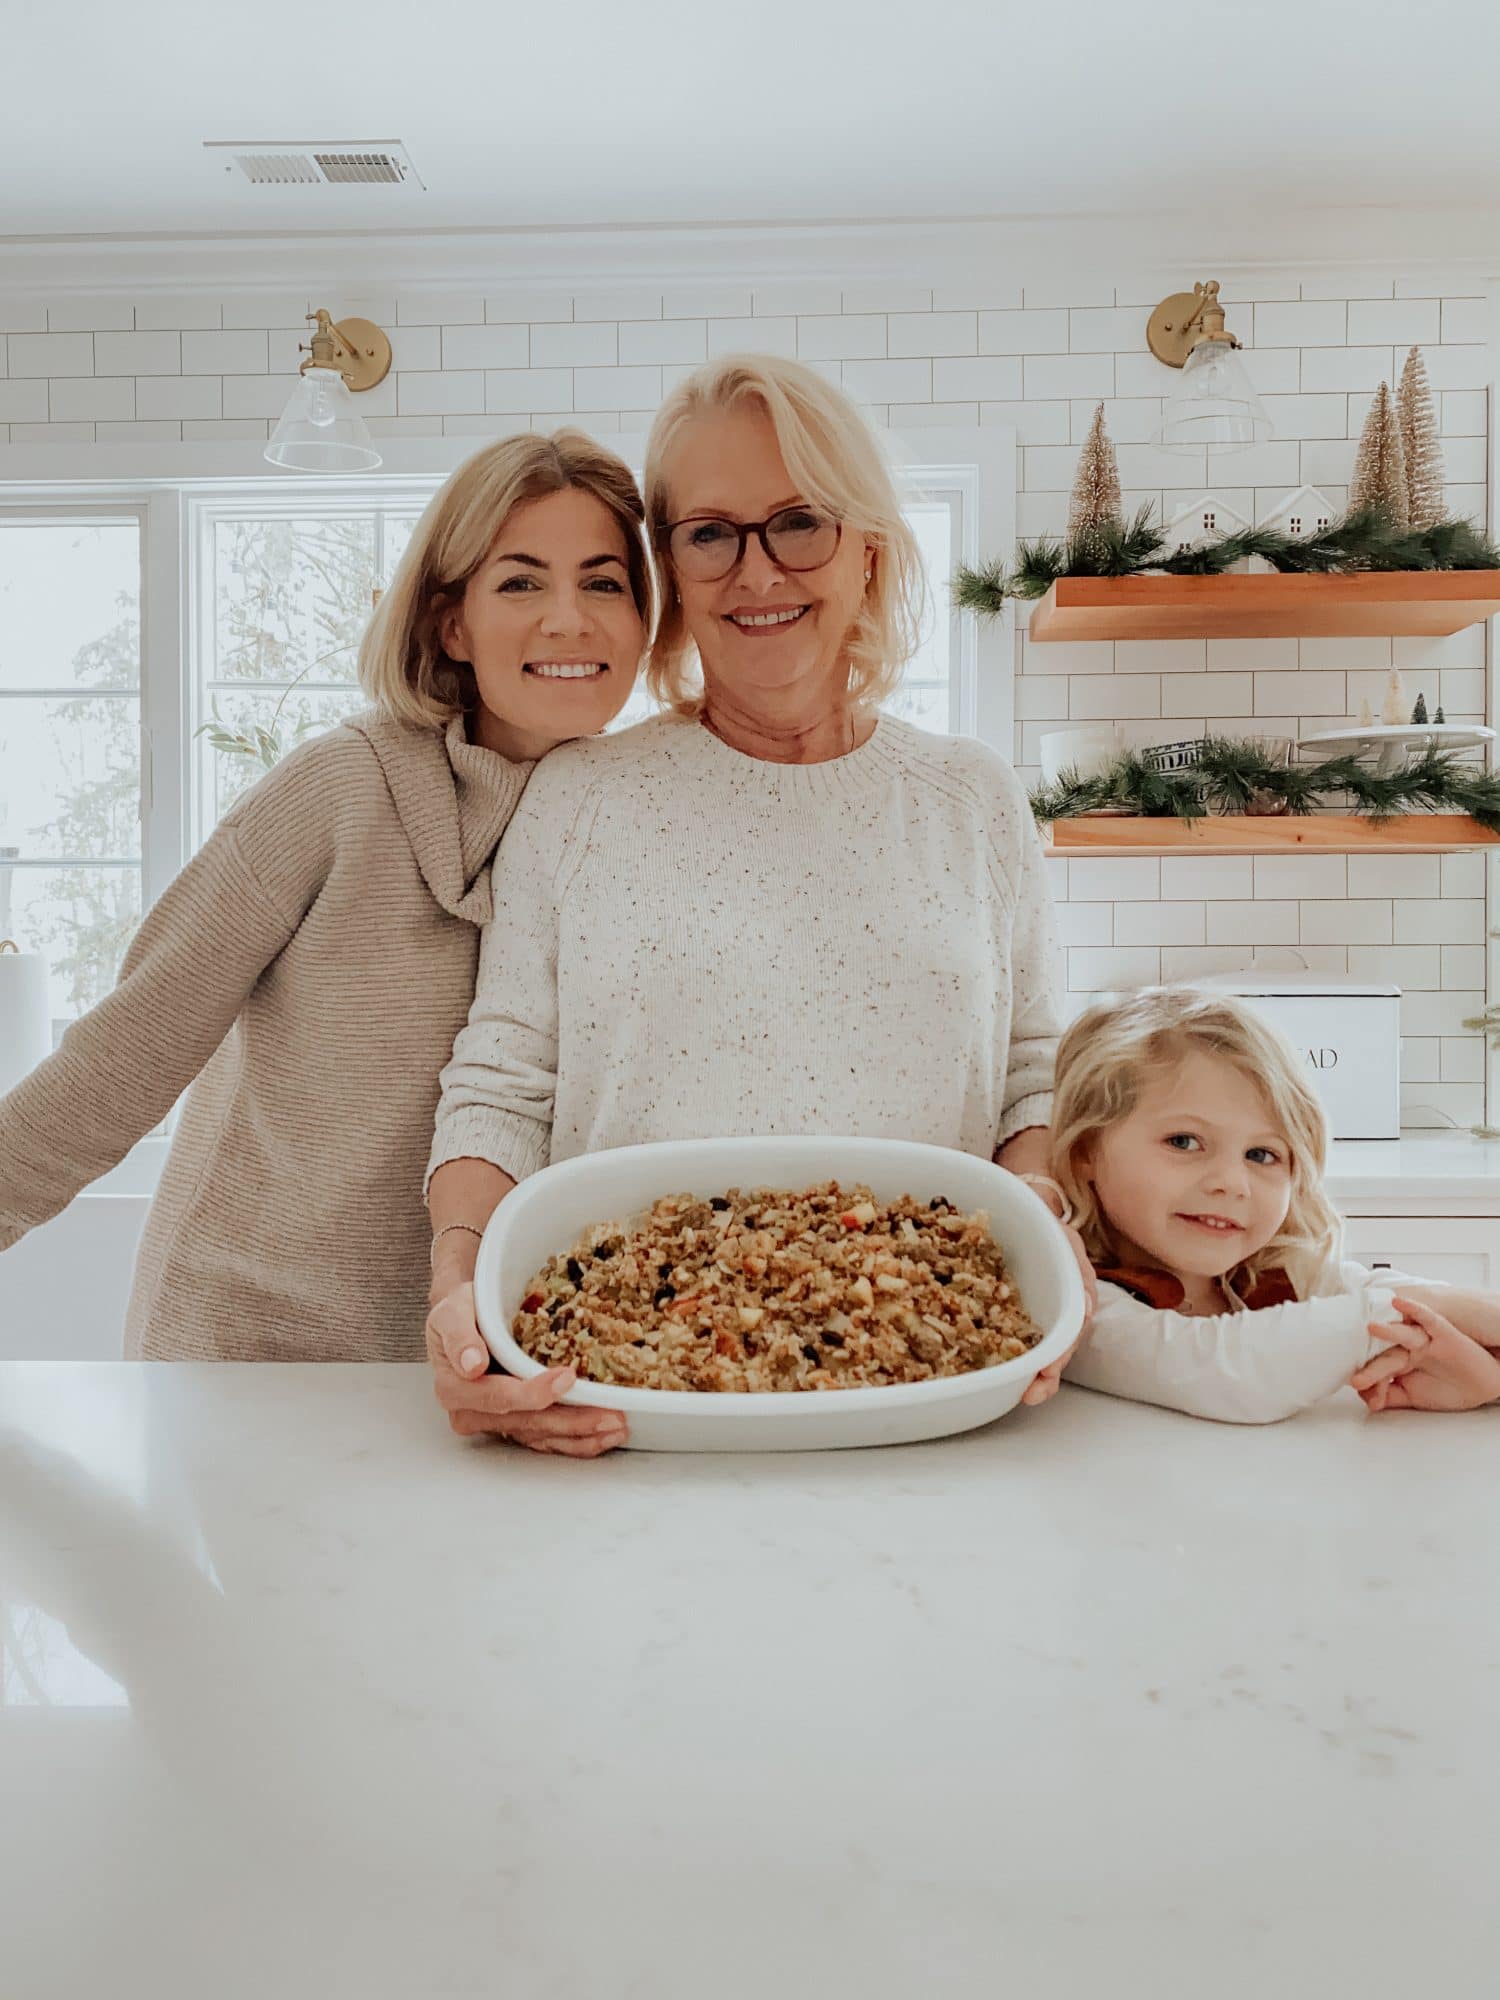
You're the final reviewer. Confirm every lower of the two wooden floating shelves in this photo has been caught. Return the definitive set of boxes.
[1048,812,1500,854]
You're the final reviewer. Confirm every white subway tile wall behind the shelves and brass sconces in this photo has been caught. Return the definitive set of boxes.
[0,272,1494,1124]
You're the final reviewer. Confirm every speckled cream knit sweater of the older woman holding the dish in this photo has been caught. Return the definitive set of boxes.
[430,716,1056,1180]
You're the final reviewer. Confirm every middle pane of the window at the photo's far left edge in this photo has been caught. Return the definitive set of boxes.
[0,694,140,860]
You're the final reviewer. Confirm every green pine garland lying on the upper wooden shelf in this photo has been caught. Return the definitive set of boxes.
[952,502,1500,618]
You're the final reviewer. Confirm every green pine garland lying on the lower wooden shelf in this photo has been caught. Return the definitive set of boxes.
[1032,736,1500,834]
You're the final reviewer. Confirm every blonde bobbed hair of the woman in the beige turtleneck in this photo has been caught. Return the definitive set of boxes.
[360,430,656,730]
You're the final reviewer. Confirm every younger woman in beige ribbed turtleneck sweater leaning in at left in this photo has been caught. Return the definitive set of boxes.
[0,430,652,1360]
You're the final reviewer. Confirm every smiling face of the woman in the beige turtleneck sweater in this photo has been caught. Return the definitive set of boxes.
[440,486,646,760]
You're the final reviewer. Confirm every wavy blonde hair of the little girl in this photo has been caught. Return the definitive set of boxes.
[1052,986,1342,1298]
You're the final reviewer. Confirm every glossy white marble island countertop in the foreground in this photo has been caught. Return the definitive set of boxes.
[0,1362,1500,2000]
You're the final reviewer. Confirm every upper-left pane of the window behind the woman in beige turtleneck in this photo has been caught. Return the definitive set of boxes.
[208,514,376,682]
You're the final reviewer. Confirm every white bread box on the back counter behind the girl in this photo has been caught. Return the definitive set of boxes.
[1194,972,1402,1138]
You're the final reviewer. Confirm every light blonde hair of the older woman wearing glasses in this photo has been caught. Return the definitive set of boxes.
[646,354,926,714]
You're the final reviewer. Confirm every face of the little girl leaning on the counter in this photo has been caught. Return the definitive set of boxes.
[1084,1048,1292,1296]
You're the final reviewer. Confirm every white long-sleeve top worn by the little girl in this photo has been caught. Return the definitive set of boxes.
[1064,1262,1432,1424]
